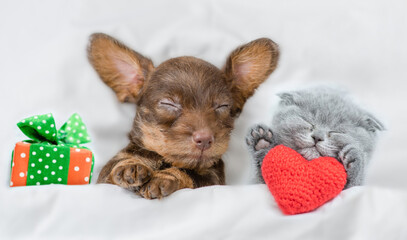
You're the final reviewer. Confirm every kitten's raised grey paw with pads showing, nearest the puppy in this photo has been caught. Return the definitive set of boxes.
[246,125,273,152]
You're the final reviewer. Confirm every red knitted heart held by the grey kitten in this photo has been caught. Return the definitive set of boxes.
[261,145,346,215]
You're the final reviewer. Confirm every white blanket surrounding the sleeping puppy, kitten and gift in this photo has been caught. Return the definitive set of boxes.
[0,0,407,239]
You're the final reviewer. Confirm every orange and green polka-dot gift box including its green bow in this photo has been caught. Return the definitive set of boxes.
[10,113,94,187]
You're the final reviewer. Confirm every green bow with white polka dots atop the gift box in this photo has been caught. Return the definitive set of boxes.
[17,113,90,145]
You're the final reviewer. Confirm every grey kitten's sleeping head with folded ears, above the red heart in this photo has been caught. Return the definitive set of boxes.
[273,89,382,160]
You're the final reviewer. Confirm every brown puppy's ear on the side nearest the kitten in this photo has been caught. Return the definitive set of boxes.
[224,38,279,112]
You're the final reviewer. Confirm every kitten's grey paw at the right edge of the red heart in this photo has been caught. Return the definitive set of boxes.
[339,147,366,189]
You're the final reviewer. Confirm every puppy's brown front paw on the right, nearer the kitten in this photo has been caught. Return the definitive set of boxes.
[139,173,180,199]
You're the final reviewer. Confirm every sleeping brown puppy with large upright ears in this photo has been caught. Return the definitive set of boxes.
[88,33,279,199]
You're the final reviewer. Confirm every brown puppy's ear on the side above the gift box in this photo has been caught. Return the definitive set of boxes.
[88,33,154,103]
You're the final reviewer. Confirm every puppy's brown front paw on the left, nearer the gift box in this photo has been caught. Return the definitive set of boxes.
[111,163,153,190]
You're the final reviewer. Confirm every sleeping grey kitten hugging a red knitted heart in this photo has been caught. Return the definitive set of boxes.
[246,87,384,188]
